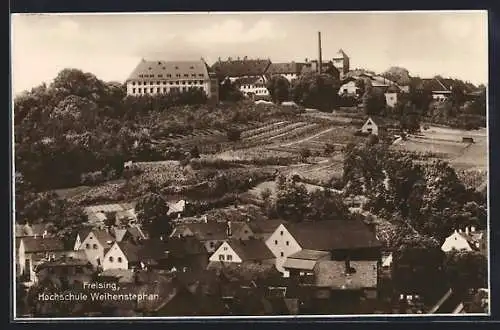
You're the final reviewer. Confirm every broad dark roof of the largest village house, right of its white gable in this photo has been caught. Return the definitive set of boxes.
[286,220,381,251]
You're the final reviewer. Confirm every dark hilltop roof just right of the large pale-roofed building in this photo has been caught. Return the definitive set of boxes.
[212,59,271,77]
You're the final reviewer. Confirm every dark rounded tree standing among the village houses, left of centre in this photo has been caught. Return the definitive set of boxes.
[135,193,172,237]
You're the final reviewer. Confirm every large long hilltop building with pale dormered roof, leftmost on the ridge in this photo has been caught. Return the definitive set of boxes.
[126,59,219,103]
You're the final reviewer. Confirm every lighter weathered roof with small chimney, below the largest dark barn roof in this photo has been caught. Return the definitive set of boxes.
[315,260,377,289]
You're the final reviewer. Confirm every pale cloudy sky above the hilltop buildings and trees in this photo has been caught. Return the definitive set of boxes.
[11,11,488,94]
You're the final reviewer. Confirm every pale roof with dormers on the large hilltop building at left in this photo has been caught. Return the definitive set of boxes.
[127,59,209,81]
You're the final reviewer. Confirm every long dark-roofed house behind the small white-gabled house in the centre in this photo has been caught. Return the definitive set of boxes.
[170,221,253,253]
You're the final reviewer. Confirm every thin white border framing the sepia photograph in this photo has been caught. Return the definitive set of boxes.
[9,9,492,323]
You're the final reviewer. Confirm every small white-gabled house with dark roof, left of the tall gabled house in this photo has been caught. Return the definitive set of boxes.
[209,239,275,264]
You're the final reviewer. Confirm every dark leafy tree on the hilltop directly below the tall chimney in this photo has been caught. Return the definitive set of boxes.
[293,73,340,111]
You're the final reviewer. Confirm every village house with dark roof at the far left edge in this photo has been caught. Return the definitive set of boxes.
[17,237,65,282]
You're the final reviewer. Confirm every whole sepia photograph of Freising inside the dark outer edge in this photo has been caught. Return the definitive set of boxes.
[11,10,490,321]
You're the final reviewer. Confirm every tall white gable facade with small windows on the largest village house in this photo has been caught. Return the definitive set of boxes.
[266,224,302,276]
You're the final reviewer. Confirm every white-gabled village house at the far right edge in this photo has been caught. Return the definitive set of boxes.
[441,226,488,255]
